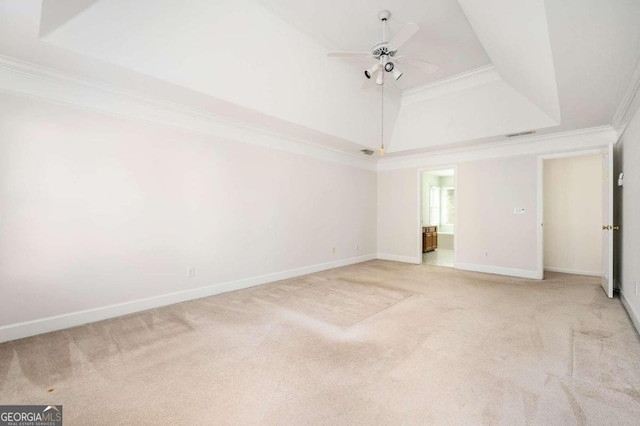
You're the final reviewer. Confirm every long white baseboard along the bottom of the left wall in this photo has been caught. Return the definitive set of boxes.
[0,254,377,343]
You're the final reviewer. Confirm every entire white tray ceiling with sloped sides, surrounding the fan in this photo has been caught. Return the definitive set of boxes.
[0,0,640,156]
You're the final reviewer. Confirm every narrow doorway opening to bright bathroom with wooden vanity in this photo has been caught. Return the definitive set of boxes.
[419,168,456,268]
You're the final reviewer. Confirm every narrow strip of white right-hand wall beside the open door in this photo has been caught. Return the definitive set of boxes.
[614,105,640,331]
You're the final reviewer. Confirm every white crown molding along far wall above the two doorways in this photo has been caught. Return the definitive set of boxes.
[378,126,617,171]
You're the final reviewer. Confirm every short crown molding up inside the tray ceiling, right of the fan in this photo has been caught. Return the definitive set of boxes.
[401,65,502,106]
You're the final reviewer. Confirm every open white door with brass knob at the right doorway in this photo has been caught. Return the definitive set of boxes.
[602,144,613,297]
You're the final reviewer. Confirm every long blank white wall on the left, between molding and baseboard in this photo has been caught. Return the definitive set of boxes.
[0,94,376,340]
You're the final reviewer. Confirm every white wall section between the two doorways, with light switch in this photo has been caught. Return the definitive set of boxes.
[456,155,537,277]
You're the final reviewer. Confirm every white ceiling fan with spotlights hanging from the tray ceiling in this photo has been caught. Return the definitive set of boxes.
[327,10,438,85]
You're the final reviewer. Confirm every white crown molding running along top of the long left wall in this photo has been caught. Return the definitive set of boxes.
[0,55,376,171]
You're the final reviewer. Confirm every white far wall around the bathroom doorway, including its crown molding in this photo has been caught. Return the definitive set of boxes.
[378,127,616,278]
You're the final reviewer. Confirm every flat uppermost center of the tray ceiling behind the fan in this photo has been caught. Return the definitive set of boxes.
[258,0,491,89]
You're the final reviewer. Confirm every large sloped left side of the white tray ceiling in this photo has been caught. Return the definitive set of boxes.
[43,0,400,147]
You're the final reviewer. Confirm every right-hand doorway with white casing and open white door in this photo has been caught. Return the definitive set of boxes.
[538,147,613,297]
